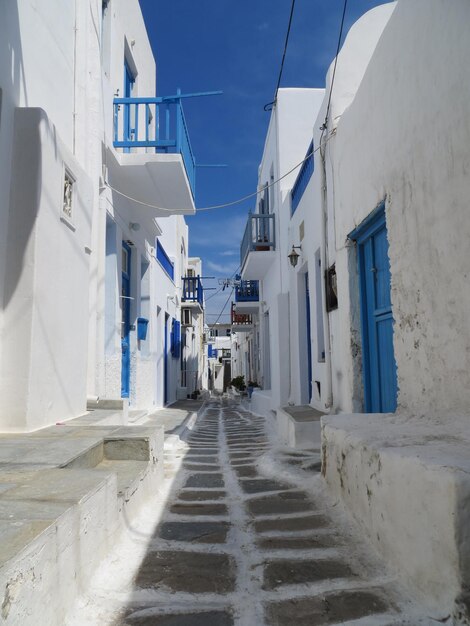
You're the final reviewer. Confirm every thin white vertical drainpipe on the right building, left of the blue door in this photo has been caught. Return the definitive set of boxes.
[320,133,333,412]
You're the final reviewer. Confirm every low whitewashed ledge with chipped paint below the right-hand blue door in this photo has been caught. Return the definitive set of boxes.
[322,414,470,623]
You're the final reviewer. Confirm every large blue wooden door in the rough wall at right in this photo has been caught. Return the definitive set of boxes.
[354,205,397,413]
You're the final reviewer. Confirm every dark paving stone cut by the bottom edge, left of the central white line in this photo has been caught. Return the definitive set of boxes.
[116,607,234,626]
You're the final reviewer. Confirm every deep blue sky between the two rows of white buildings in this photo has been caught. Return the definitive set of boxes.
[140,0,383,324]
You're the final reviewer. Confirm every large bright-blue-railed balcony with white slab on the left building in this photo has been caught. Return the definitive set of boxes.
[107,95,196,217]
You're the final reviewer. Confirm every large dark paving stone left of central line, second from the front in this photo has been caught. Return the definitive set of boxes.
[135,551,236,593]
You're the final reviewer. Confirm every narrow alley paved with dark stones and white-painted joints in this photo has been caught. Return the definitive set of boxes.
[67,398,437,626]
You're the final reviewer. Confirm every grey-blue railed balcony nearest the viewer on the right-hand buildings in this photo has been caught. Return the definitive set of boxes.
[240,213,276,280]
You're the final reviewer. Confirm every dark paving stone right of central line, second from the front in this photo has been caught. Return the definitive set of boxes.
[263,559,353,589]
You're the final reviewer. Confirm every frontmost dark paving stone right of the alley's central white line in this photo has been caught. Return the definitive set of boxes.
[265,591,391,626]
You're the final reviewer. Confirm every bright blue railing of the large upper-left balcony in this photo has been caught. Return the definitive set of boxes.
[113,96,196,197]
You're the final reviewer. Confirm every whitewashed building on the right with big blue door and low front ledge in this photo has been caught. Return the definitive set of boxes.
[240,0,470,624]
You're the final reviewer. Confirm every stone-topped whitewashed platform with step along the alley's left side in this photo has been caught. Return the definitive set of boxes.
[0,416,163,626]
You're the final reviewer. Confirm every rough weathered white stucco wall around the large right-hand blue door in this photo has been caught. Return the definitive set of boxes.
[330,0,470,414]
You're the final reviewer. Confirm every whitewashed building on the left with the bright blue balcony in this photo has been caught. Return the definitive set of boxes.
[0,0,207,431]
